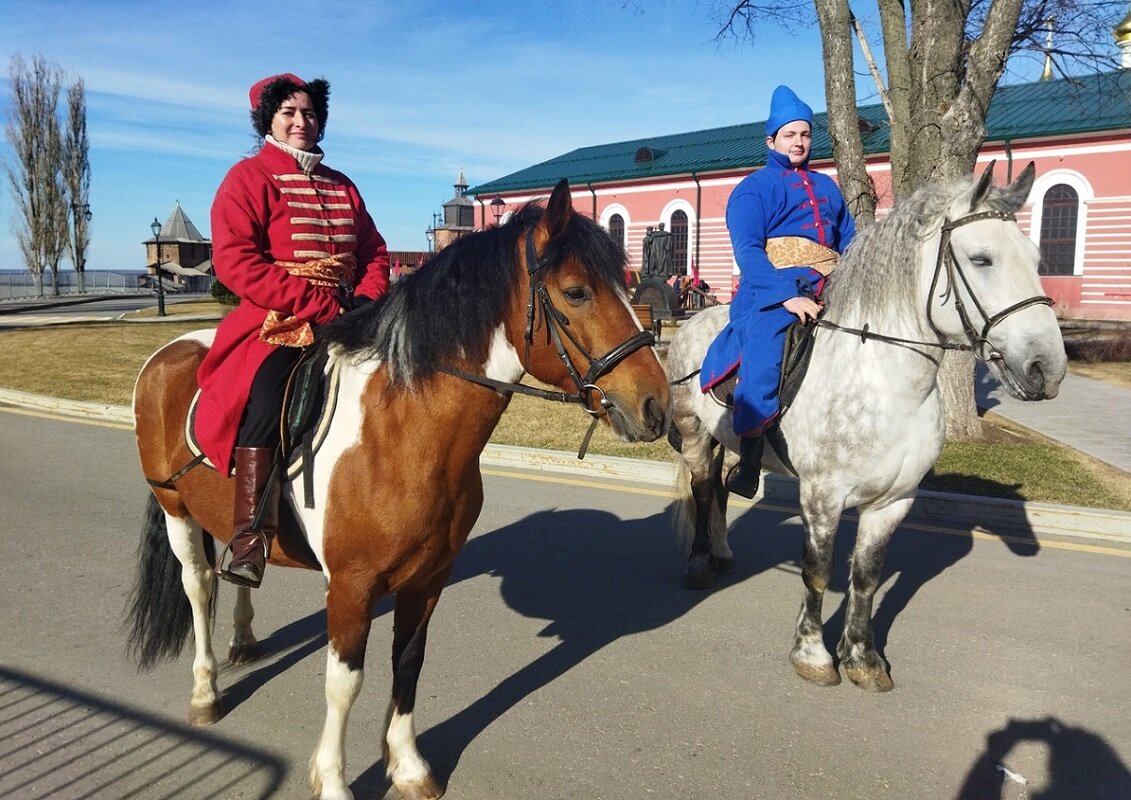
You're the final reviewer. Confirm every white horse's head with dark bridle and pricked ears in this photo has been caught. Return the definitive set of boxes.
[924,162,1067,399]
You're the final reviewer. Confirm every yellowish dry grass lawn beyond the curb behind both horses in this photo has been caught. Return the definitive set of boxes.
[0,301,1131,511]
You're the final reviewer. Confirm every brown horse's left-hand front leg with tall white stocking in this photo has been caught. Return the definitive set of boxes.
[310,573,373,800]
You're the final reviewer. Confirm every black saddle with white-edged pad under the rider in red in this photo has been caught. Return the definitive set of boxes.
[184,346,340,508]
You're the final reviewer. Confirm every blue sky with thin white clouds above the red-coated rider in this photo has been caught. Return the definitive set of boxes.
[0,0,1058,269]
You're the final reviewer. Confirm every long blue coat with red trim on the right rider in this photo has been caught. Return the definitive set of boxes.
[699,150,856,436]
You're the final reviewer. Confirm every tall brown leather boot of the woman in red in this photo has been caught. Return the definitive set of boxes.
[219,447,279,588]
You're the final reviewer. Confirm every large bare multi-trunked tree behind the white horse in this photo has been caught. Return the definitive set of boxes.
[715,0,1125,439]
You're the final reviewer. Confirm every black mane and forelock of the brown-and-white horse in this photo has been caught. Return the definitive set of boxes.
[321,203,627,385]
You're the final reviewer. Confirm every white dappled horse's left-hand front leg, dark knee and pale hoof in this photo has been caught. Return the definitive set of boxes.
[789,493,843,686]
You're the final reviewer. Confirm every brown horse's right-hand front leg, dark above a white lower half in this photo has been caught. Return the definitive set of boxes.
[385,570,448,800]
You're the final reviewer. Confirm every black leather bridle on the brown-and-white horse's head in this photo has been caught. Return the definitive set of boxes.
[437,230,656,458]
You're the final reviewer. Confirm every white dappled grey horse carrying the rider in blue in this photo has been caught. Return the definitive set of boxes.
[667,159,1067,691]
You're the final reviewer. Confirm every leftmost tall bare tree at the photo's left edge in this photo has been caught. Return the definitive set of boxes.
[5,55,68,296]
